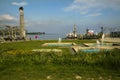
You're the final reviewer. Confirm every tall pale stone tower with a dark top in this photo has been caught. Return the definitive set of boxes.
[19,7,26,39]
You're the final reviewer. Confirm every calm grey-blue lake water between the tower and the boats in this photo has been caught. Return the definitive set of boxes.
[27,34,66,40]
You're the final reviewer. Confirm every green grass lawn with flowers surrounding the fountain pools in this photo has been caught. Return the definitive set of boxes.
[0,40,120,80]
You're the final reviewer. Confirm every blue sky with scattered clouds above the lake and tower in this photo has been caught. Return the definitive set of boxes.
[0,0,120,33]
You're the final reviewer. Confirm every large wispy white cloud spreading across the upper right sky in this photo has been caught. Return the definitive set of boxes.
[64,0,120,16]
